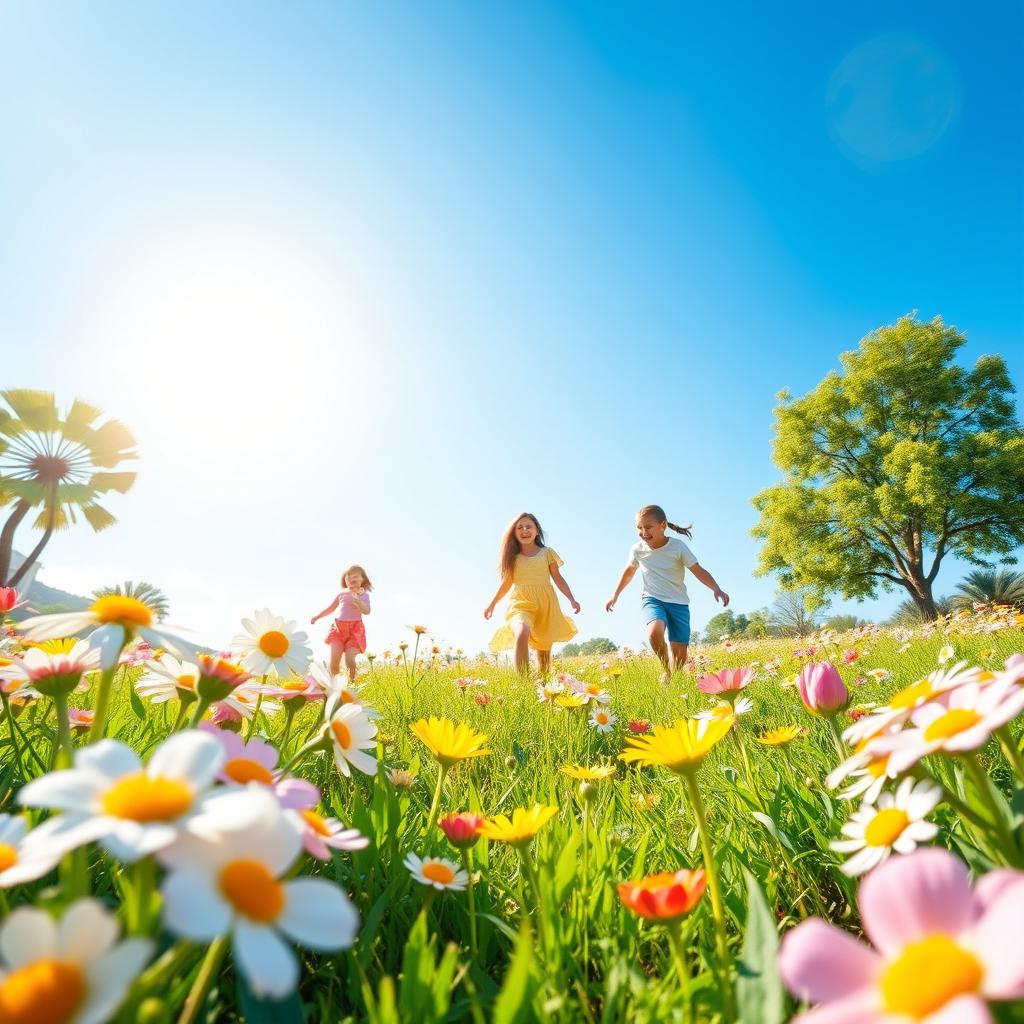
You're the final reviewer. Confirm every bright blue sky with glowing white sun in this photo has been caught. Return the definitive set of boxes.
[0,2,1024,650]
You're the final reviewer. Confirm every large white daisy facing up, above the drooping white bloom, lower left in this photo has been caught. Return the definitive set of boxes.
[18,731,224,862]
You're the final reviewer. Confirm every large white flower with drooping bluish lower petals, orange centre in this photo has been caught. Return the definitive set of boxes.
[160,786,358,997]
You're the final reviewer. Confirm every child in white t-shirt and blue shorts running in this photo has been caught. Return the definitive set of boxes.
[604,505,729,683]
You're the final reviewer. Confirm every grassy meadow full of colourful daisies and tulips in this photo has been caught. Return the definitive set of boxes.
[0,596,1024,1024]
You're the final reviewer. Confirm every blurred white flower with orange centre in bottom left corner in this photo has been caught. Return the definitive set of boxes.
[0,899,153,1024]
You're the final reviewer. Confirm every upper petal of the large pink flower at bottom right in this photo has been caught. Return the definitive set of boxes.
[857,849,976,959]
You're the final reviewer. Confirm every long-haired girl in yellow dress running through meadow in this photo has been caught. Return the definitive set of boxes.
[483,512,580,674]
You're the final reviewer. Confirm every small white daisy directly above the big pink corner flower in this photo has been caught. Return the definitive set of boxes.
[828,778,942,878]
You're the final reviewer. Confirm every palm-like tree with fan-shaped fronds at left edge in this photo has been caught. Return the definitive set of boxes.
[0,388,136,587]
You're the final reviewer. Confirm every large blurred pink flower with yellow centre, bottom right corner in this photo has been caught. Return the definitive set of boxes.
[779,848,1024,1024]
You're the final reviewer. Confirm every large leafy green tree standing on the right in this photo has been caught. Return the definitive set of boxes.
[753,315,1024,618]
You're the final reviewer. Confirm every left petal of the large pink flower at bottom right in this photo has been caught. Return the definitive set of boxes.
[778,918,883,1002]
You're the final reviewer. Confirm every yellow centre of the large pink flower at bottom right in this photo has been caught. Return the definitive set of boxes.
[882,934,985,1020]
